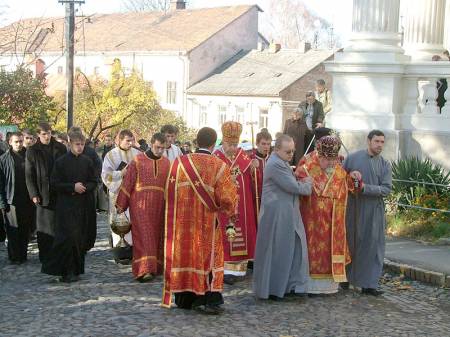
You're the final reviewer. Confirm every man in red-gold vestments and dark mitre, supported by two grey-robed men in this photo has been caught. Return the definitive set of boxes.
[296,136,361,294]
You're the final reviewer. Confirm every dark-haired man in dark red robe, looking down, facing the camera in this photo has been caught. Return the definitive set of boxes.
[116,133,170,282]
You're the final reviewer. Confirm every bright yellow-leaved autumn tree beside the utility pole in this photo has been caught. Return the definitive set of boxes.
[52,59,195,140]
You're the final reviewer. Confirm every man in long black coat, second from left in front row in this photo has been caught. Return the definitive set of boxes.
[25,122,67,263]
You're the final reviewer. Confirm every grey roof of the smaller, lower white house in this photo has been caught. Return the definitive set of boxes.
[187,49,335,96]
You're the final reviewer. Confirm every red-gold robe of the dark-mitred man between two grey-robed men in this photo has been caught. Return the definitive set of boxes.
[296,153,353,282]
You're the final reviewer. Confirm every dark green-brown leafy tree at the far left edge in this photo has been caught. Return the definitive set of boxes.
[0,67,55,128]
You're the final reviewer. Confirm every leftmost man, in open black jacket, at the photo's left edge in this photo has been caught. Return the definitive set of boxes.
[0,132,35,264]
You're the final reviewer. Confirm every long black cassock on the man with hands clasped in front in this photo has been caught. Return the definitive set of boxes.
[42,152,97,276]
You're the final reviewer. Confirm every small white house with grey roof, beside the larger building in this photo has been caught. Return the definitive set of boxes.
[186,45,334,141]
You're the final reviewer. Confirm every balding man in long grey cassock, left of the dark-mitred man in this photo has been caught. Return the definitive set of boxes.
[253,135,312,300]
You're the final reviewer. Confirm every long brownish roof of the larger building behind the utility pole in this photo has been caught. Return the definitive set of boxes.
[0,5,260,53]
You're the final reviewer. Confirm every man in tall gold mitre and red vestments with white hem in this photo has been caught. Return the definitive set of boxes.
[214,122,258,284]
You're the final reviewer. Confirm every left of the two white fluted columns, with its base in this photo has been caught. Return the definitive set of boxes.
[346,0,403,53]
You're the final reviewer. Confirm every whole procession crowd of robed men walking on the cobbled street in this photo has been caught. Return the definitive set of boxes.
[0,78,392,314]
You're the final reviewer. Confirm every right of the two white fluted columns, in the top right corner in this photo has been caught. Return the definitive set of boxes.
[404,0,446,61]
